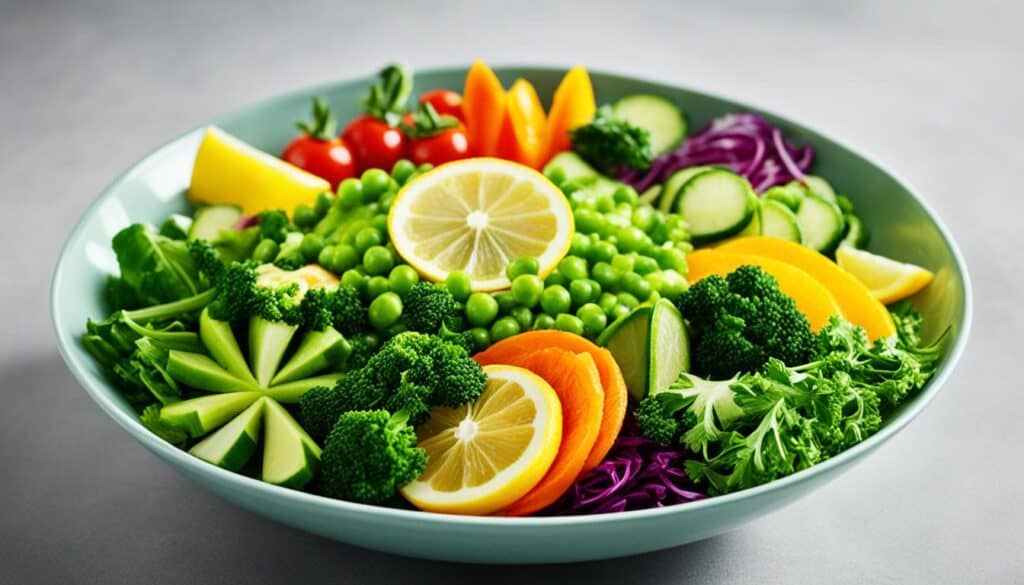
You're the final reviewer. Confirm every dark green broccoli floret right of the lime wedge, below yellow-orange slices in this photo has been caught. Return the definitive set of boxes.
[678,265,817,379]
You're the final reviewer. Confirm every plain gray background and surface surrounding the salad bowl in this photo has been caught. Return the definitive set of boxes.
[0,0,1024,585]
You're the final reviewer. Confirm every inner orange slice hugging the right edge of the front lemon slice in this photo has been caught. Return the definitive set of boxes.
[475,347,603,516]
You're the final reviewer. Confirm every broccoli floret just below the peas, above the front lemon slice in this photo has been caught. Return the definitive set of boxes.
[299,332,486,440]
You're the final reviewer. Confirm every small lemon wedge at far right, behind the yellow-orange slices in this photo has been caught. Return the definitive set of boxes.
[836,246,934,304]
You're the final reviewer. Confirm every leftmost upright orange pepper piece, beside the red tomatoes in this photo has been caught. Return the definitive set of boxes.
[462,59,506,157]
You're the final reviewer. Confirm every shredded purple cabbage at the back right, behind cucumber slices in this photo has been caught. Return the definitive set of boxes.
[617,114,814,193]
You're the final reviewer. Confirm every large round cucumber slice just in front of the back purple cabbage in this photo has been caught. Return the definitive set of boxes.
[675,169,758,244]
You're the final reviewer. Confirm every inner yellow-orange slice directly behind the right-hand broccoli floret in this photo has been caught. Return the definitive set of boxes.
[686,249,843,331]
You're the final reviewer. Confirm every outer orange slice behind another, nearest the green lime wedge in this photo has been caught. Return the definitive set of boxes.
[476,329,629,471]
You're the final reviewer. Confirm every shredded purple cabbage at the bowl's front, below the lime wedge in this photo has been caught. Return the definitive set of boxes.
[544,424,707,515]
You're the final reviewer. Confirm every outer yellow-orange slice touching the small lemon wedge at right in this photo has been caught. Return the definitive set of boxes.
[716,236,896,341]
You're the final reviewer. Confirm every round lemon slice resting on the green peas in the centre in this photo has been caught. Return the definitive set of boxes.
[388,159,573,291]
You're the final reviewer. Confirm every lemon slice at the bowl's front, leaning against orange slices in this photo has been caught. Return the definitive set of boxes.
[401,366,562,514]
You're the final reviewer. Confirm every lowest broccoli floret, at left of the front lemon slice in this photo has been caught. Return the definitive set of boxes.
[321,410,427,504]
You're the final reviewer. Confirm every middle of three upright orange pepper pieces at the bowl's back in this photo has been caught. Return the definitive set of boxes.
[498,79,548,169]
